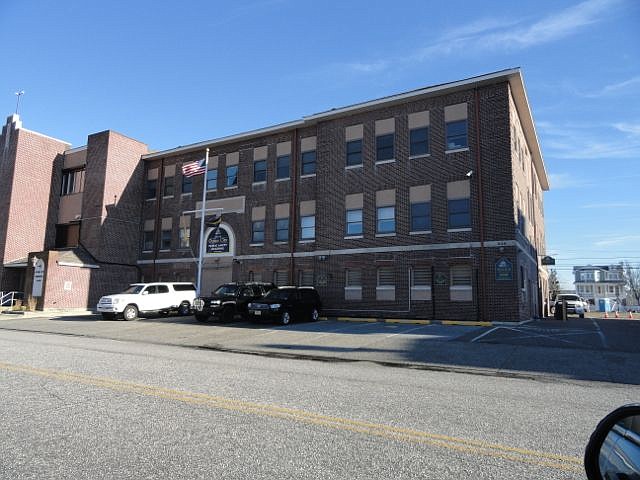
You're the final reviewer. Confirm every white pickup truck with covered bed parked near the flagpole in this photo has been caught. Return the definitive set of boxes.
[97,282,196,320]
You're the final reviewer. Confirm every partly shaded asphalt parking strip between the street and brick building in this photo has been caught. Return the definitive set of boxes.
[0,315,640,384]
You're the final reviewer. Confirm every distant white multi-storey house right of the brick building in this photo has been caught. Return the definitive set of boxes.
[573,265,625,305]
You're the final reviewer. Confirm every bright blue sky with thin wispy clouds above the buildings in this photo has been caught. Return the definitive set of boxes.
[0,0,640,287]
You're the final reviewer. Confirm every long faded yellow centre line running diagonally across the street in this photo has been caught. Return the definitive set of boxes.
[0,362,582,472]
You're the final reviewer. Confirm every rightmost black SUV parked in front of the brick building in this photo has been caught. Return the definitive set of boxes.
[248,287,322,325]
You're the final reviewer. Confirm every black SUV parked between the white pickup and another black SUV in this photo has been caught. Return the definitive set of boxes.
[193,282,276,322]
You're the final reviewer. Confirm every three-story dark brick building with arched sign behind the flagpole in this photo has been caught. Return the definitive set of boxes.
[0,69,548,320]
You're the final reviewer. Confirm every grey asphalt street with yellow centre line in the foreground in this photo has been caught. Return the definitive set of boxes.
[0,330,640,480]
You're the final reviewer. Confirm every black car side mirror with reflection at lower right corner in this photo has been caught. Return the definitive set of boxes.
[584,404,640,480]
